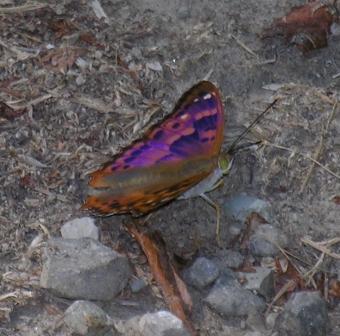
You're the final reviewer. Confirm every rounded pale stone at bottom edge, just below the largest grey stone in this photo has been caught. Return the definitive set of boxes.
[64,301,112,335]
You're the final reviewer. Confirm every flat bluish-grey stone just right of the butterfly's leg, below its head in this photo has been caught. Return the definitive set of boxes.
[224,193,271,223]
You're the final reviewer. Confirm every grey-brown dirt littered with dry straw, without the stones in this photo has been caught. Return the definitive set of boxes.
[0,0,340,335]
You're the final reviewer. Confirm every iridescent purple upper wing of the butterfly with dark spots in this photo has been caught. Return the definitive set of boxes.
[89,81,224,188]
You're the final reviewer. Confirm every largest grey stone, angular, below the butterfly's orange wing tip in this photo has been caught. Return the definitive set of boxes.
[40,238,131,300]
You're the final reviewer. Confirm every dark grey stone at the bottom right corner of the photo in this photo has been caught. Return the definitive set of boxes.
[274,292,329,336]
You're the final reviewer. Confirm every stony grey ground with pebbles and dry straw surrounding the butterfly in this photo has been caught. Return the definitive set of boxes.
[0,0,340,336]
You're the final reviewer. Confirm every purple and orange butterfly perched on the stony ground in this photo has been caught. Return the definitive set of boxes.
[83,81,230,244]
